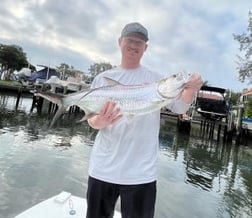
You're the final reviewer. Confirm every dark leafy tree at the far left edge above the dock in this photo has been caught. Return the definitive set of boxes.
[0,44,28,79]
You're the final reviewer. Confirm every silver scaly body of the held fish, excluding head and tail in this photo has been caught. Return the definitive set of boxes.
[77,83,165,114]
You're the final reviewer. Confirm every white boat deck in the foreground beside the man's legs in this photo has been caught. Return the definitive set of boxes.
[15,191,121,218]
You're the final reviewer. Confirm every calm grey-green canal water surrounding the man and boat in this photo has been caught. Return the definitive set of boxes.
[0,94,252,218]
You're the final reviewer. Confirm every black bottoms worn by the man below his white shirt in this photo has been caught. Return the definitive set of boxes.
[86,177,156,218]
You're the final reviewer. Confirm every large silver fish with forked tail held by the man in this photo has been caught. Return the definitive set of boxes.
[36,73,189,126]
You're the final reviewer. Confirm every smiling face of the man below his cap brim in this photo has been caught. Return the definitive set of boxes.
[119,35,147,61]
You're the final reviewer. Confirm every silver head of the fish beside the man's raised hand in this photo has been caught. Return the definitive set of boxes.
[158,72,189,98]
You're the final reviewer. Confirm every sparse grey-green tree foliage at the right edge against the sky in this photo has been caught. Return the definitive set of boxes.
[233,12,252,84]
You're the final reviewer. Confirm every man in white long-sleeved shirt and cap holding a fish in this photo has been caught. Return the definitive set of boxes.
[87,23,202,218]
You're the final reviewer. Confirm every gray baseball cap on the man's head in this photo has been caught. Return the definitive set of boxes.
[121,22,149,42]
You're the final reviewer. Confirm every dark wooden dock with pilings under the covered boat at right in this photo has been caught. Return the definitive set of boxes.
[161,105,252,145]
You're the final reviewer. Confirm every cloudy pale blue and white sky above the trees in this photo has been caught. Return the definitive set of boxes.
[0,0,252,92]
